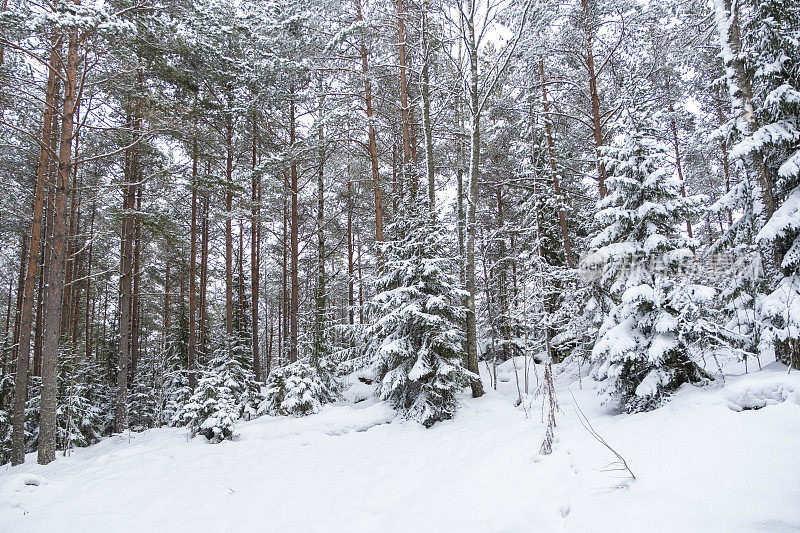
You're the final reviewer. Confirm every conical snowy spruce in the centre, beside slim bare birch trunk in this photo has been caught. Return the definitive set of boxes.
[364,202,472,427]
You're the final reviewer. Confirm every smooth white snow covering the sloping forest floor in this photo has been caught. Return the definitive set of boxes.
[0,362,800,533]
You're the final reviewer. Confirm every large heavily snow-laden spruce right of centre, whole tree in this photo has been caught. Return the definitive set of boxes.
[589,116,709,411]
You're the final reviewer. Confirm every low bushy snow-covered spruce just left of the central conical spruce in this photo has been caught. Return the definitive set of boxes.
[258,361,339,416]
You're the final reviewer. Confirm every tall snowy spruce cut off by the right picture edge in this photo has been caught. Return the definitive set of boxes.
[748,0,800,368]
